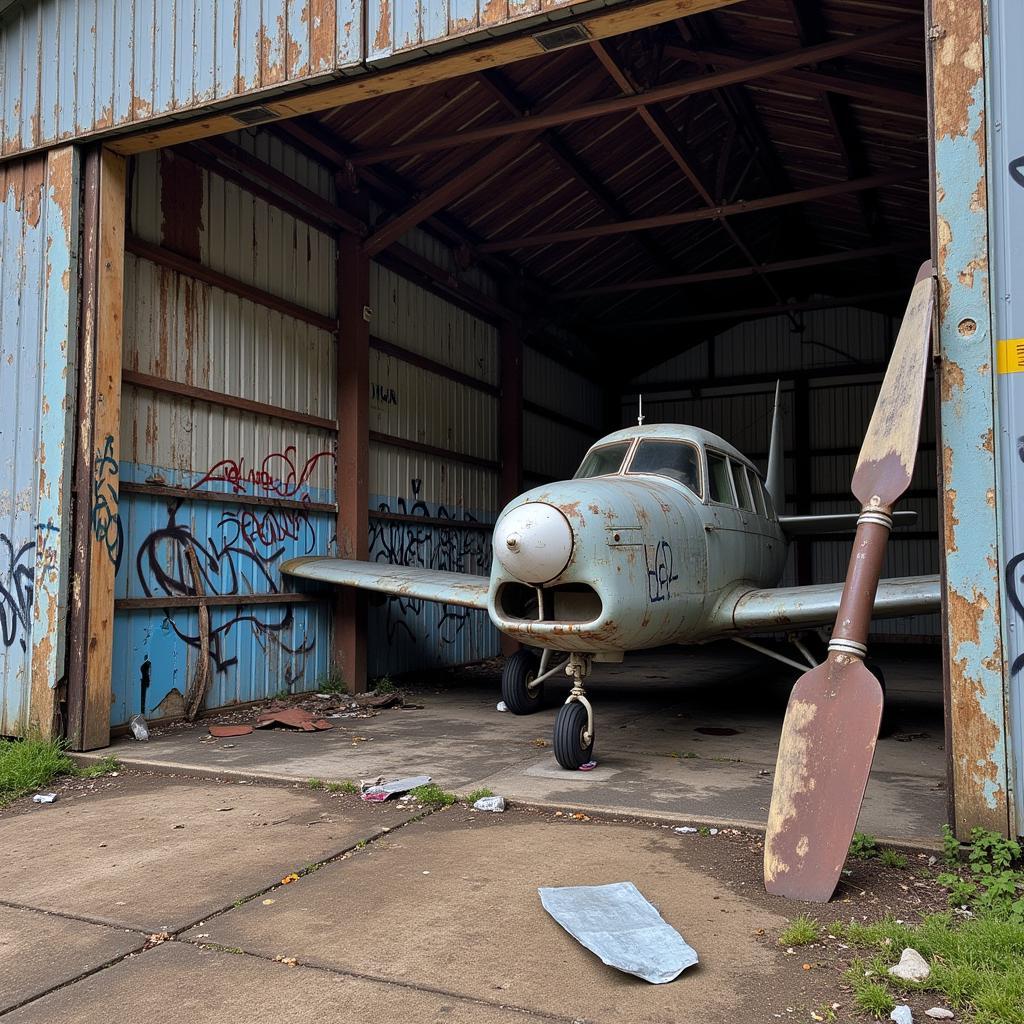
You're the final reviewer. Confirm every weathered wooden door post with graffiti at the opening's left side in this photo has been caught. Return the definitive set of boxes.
[78,150,125,751]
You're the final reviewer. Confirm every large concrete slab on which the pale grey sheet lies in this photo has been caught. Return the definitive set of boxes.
[184,808,785,1024]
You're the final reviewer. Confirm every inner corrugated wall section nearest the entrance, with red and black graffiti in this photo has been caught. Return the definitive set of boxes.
[111,134,336,725]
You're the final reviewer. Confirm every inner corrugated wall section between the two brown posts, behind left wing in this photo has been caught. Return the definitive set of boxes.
[368,220,501,676]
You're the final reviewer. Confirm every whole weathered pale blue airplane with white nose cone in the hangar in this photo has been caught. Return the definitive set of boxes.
[282,276,940,778]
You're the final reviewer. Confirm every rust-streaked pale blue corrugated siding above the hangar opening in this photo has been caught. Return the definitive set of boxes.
[0,0,578,156]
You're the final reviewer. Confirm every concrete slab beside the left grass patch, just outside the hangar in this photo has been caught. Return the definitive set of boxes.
[0,779,419,932]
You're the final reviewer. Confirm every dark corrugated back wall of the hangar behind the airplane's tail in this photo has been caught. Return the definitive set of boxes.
[623,309,940,637]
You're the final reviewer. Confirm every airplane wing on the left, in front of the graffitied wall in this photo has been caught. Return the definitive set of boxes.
[281,555,490,608]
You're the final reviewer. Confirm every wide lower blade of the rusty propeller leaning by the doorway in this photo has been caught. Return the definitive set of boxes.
[764,655,883,903]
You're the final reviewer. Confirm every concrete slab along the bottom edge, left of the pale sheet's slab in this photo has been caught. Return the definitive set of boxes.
[4,942,536,1024]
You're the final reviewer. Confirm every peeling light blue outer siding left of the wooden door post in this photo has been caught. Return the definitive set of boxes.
[0,147,79,735]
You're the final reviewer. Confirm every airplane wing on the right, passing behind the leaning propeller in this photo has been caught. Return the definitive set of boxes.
[732,575,942,633]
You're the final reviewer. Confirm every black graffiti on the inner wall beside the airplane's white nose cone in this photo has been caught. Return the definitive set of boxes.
[370,479,492,644]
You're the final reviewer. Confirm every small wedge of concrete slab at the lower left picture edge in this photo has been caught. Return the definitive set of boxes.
[0,906,145,1012]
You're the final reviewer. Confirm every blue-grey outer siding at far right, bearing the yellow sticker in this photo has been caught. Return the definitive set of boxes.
[988,0,1024,835]
